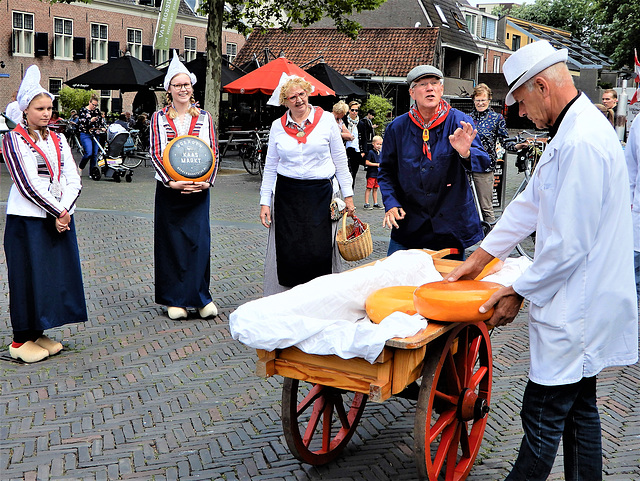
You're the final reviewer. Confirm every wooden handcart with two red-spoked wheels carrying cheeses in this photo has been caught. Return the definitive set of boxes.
[256,255,492,481]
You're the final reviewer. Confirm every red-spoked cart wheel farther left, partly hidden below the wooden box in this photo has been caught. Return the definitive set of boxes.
[282,378,368,465]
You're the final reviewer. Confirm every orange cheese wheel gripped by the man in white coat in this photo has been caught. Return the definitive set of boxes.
[413,280,502,322]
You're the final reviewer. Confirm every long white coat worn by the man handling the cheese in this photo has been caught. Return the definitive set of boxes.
[481,94,638,385]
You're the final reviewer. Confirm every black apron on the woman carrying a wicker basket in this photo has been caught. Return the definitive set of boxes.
[274,175,333,287]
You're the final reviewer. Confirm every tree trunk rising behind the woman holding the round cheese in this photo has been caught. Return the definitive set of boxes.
[204,0,224,130]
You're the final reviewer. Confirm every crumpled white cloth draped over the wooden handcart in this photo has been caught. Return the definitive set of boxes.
[229,250,442,362]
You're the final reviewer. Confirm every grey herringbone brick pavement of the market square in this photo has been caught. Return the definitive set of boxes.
[0,153,640,481]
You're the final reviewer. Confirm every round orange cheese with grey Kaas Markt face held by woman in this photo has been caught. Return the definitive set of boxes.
[162,135,216,182]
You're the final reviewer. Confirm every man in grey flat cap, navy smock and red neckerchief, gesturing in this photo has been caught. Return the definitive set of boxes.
[378,65,491,258]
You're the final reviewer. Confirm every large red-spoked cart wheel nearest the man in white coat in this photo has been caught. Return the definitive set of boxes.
[414,322,492,481]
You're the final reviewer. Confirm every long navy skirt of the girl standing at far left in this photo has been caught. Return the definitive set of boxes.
[4,215,87,331]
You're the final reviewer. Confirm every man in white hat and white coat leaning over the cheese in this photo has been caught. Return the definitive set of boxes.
[448,41,638,481]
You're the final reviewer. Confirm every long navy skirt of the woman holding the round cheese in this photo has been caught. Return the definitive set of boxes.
[153,182,212,308]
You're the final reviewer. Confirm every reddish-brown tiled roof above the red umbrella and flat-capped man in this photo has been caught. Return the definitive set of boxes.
[234,28,438,77]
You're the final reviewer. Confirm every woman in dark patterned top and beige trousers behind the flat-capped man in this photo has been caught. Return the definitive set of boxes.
[471,84,513,224]
